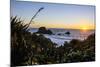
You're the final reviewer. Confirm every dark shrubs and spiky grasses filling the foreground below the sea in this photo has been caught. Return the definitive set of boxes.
[11,17,95,66]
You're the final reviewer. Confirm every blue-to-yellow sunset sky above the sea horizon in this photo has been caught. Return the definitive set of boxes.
[11,0,95,29]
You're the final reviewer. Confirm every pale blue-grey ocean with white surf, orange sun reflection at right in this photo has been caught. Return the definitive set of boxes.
[29,28,95,46]
